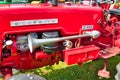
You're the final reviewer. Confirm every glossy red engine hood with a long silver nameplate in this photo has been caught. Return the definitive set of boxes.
[0,4,103,39]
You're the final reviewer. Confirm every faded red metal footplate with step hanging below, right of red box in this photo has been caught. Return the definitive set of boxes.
[98,47,120,78]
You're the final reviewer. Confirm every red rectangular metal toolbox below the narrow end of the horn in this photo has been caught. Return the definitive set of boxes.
[64,45,100,65]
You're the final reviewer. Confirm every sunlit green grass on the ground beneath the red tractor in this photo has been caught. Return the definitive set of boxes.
[26,56,120,80]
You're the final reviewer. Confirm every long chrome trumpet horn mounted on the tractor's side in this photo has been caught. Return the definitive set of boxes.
[28,30,100,53]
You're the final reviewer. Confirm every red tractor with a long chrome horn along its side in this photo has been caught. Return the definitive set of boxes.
[0,0,120,80]
